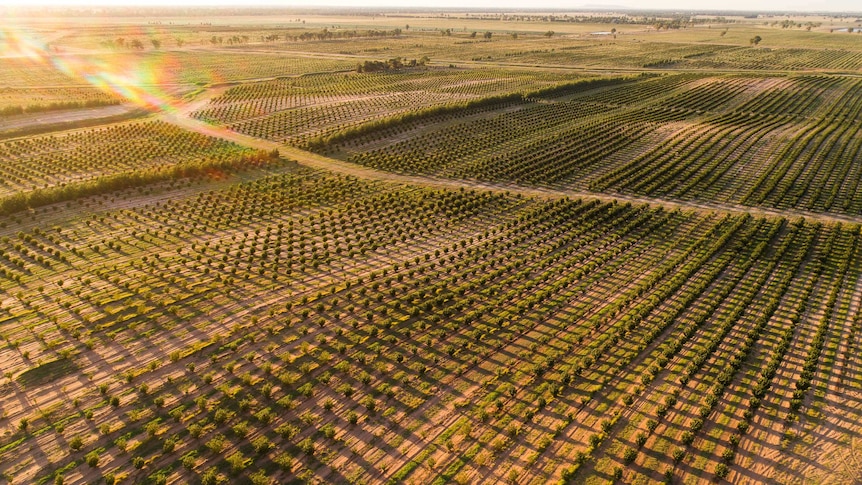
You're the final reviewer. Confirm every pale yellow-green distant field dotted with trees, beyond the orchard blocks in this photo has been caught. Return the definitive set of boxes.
[231,25,862,73]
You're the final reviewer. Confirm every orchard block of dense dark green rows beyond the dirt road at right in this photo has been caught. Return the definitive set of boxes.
[340,74,862,214]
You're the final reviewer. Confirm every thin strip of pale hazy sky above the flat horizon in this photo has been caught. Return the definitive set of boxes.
[0,0,862,12]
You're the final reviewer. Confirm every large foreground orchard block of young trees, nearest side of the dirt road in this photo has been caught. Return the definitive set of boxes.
[0,168,862,483]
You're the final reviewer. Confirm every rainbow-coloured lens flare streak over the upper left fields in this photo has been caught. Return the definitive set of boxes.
[0,27,178,112]
